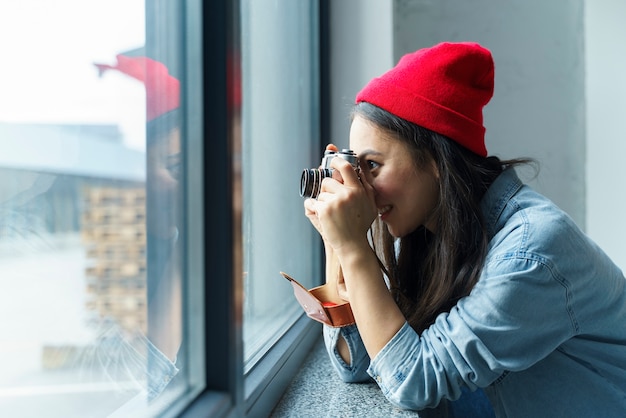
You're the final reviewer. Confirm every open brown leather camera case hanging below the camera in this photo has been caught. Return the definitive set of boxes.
[280,271,354,328]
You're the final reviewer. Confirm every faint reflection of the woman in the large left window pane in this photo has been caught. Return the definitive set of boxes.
[95,54,185,404]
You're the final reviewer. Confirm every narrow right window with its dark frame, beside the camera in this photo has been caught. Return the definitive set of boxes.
[195,0,323,417]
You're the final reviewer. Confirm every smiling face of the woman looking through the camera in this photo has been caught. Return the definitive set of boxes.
[350,116,439,238]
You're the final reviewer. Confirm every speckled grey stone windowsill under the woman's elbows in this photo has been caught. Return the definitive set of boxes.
[271,333,447,418]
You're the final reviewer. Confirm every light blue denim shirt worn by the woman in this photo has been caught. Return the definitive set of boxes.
[324,169,626,417]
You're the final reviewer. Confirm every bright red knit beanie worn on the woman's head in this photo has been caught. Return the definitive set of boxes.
[356,42,494,157]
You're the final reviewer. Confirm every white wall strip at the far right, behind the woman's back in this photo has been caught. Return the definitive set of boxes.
[585,0,626,270]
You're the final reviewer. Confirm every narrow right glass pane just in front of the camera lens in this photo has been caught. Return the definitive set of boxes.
[241,0,322,370]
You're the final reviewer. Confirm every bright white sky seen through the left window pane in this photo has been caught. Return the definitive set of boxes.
[0,0,145,149]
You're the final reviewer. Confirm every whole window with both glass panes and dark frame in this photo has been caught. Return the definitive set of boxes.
[0,0,324,417]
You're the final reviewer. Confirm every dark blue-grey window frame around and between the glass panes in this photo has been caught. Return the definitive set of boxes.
[177,0,330,417]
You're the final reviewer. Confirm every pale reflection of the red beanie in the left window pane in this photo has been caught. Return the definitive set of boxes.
[94,54,180,121]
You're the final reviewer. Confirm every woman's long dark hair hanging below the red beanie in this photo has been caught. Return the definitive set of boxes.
[352,102,530,332]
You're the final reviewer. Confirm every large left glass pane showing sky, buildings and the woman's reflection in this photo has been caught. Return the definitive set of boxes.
[0,0,197,417]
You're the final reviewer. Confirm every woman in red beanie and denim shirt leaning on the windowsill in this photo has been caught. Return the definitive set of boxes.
[304,43,626,417]
